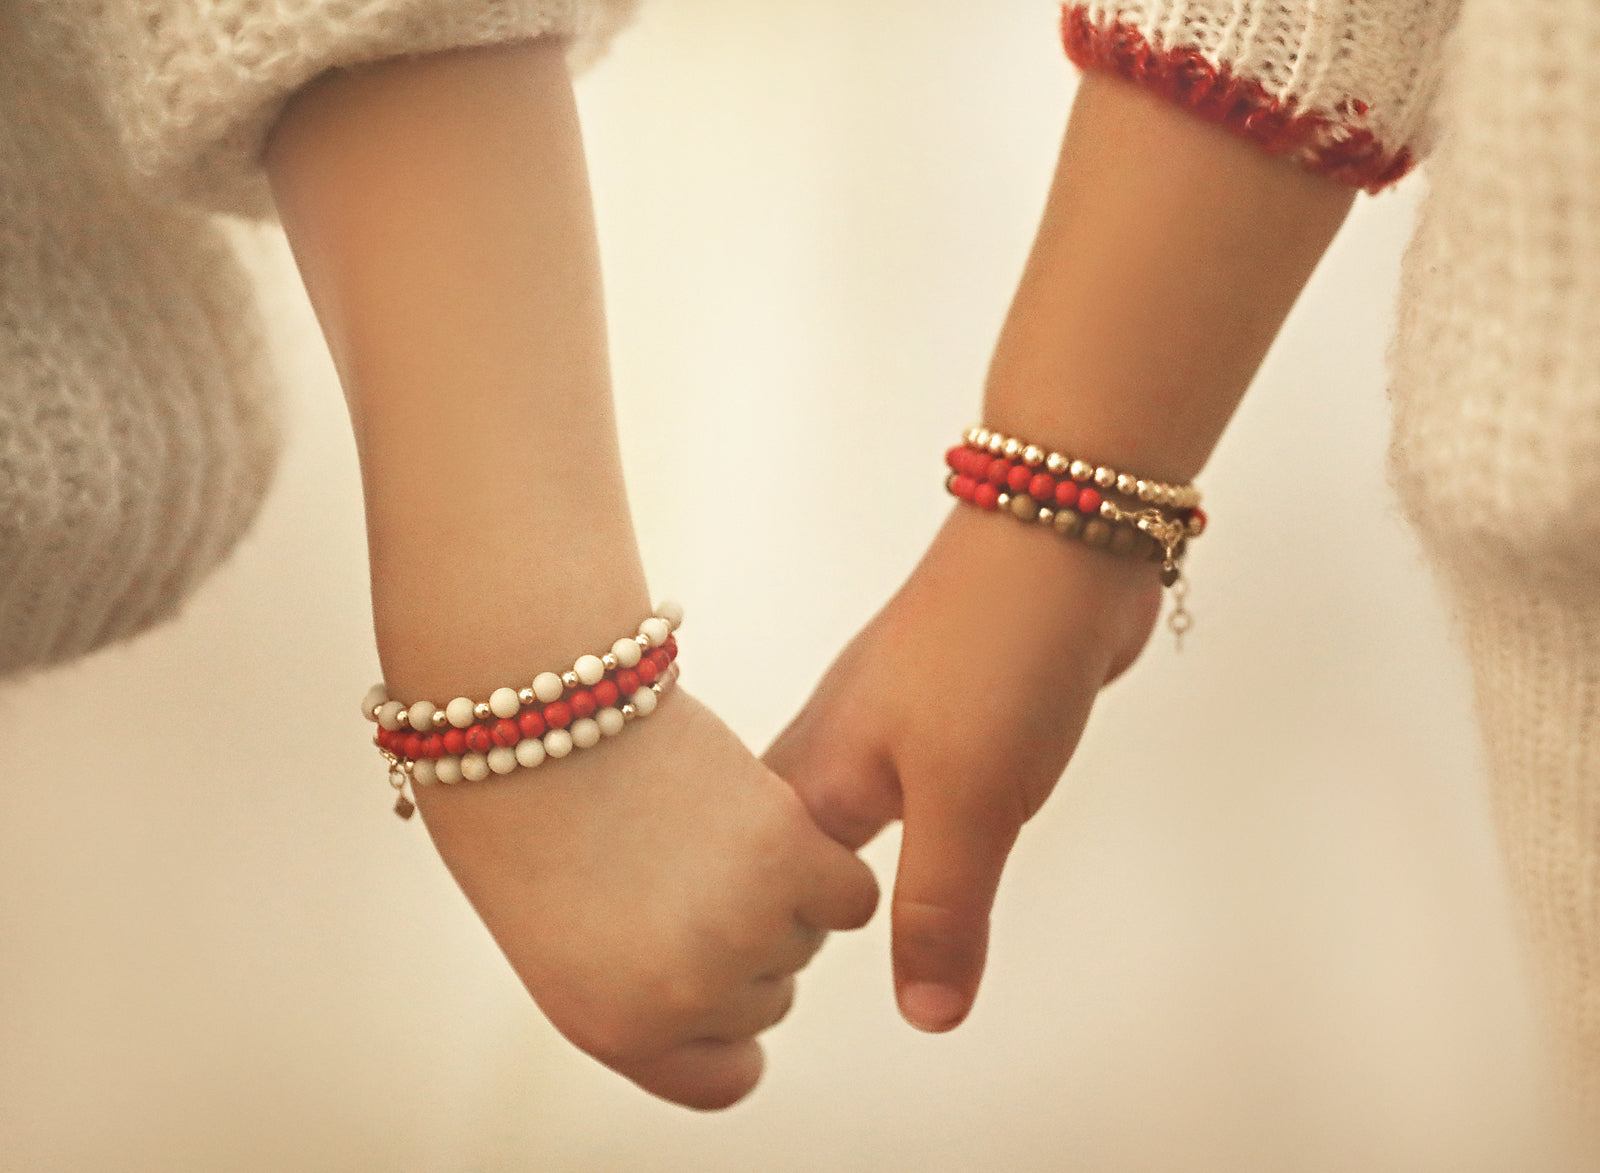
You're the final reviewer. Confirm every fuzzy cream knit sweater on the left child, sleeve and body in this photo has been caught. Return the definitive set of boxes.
[0,0,634,677]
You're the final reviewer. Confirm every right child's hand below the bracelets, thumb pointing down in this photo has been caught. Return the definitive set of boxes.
[765,507,1160,1031]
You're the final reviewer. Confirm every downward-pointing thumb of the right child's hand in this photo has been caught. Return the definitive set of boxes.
[893,786,1022,1031]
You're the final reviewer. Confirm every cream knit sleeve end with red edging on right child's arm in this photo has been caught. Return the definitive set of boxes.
[1061,0,1459,192]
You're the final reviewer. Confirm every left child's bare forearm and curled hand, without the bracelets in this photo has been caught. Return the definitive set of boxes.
[266,40,877,1109]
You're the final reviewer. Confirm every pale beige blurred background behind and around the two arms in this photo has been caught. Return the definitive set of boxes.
[0,0,1544,1173]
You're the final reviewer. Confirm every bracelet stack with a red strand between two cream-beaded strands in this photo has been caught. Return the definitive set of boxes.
[362,603,683,819]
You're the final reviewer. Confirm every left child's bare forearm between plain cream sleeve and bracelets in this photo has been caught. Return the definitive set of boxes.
[266,40,648,698]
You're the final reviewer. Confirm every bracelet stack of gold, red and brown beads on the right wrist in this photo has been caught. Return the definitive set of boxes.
[944,427,1205,637]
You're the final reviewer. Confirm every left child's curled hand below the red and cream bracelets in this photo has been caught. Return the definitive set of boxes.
[418,690,877,1109]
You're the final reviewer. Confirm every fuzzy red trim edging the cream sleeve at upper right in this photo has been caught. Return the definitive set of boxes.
[1061,5,1416,192]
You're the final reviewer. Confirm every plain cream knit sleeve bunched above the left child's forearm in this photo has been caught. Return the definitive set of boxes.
[24,0,637,218]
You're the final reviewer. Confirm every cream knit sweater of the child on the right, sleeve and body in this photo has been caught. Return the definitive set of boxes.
[1064,0,1600,1130]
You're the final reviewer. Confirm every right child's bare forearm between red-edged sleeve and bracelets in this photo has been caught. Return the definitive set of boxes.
[984,72,1354,482]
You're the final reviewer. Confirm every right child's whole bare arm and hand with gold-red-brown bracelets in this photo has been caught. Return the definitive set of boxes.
[766,74,1352,1031]
